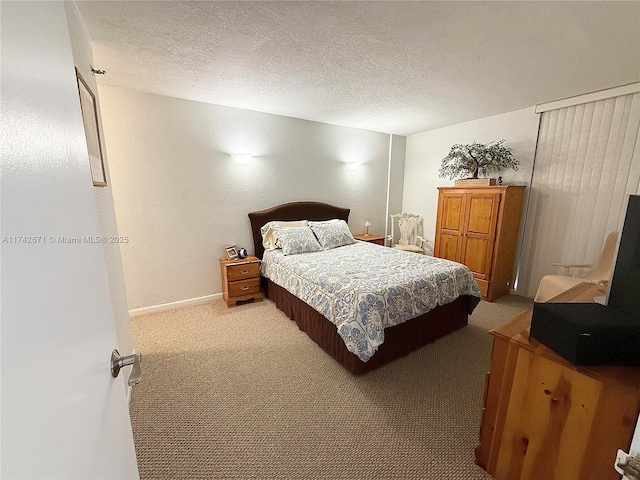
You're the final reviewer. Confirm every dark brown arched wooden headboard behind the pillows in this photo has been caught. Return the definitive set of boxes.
[249,202,351,258]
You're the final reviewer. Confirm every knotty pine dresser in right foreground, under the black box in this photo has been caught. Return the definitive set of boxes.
[475,283,640,480]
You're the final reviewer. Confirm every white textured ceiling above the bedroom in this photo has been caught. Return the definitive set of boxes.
[77,1,640,135]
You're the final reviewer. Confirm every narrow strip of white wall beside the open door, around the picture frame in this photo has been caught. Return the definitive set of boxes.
[65,2,133,358]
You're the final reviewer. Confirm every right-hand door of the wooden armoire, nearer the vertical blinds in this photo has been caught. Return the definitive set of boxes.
[461,192,500,281]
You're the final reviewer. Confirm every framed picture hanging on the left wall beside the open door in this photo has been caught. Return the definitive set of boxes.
[76,68,107,187]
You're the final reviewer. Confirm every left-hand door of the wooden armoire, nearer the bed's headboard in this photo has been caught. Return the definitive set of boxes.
[434,192,466,262]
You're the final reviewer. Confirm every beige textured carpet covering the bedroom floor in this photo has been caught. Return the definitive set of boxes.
[131,296,532,479]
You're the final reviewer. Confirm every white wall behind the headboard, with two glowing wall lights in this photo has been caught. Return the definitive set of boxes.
[99,86,389,309]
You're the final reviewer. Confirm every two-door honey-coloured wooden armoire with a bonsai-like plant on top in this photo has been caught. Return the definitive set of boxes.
[434,185,526,302]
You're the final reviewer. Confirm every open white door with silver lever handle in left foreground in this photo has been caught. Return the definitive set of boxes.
[0,2,138,479]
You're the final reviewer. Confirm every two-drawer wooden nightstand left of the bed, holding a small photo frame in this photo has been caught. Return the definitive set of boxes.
[220,257,262,307]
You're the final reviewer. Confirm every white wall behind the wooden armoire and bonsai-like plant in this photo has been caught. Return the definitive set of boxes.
[402,107,538,251]
